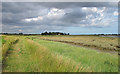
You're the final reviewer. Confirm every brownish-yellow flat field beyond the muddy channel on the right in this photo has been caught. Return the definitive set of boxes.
[38,36,118,51]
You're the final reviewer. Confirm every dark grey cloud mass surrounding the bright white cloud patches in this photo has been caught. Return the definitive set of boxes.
[2,2,117,32]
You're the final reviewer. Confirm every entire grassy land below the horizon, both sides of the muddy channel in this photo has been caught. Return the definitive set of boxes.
[0,35,118,72]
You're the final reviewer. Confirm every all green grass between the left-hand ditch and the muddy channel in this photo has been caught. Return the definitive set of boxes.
[2,36,118,72]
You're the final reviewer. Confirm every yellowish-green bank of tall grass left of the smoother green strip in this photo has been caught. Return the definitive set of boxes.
[3,39,92,72]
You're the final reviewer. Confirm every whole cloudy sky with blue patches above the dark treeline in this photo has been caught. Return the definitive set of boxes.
[2,2,118,35]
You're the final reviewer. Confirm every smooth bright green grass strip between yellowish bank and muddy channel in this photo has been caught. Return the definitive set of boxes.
[35,39,118,72]
